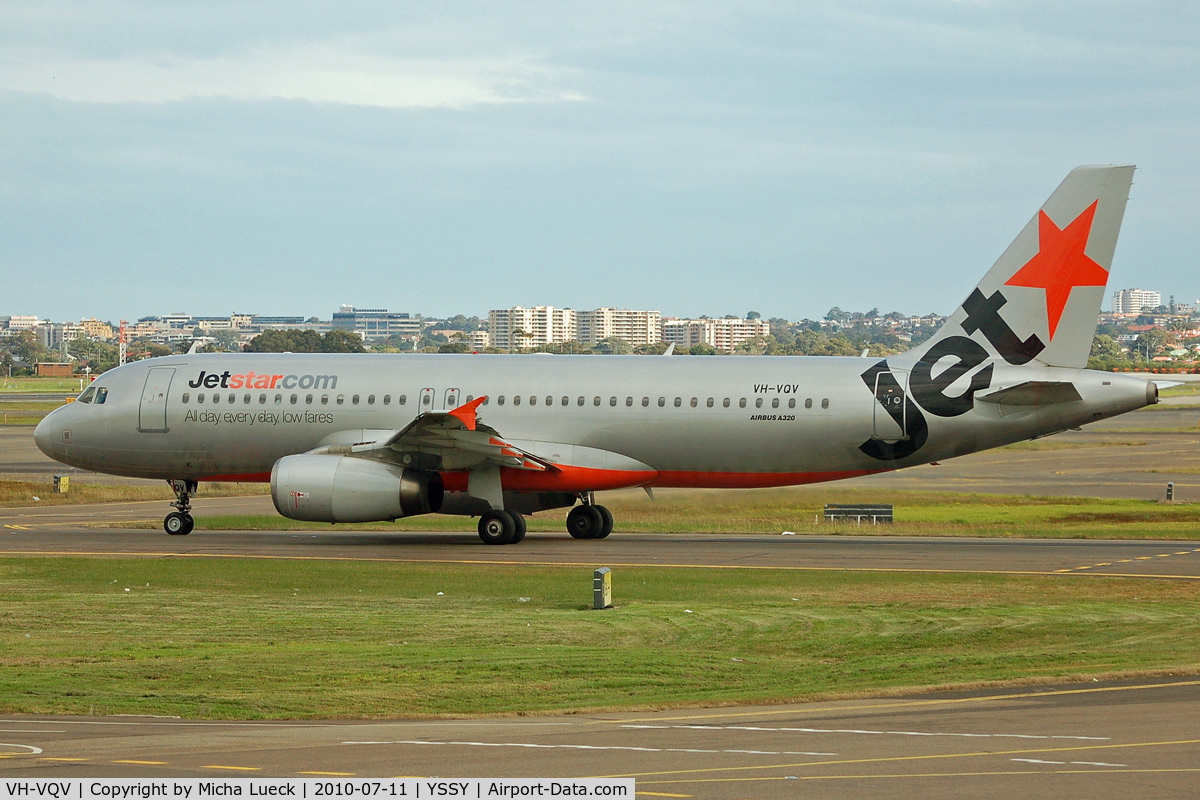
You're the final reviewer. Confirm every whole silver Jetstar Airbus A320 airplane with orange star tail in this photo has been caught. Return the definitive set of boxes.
[34,166,1158,545]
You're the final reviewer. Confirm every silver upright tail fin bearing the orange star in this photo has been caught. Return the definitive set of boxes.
[914,166,1134,367]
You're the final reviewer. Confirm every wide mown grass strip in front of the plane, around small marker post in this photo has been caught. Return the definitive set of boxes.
[0,558,1200,718]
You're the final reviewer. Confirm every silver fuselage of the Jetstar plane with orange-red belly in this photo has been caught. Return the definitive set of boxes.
[36,354,1153,492]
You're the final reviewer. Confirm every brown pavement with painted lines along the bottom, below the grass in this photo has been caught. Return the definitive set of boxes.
[0,676,1200,800]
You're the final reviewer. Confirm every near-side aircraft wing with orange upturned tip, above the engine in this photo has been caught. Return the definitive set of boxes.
[314,397,558,471]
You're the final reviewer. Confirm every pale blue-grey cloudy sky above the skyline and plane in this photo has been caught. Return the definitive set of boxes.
[0,0,1200,319]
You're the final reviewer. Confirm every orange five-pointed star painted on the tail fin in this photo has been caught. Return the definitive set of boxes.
[1004,200,1109,341]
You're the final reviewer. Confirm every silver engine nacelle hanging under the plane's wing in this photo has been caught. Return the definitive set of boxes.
[271,455,444,522]
